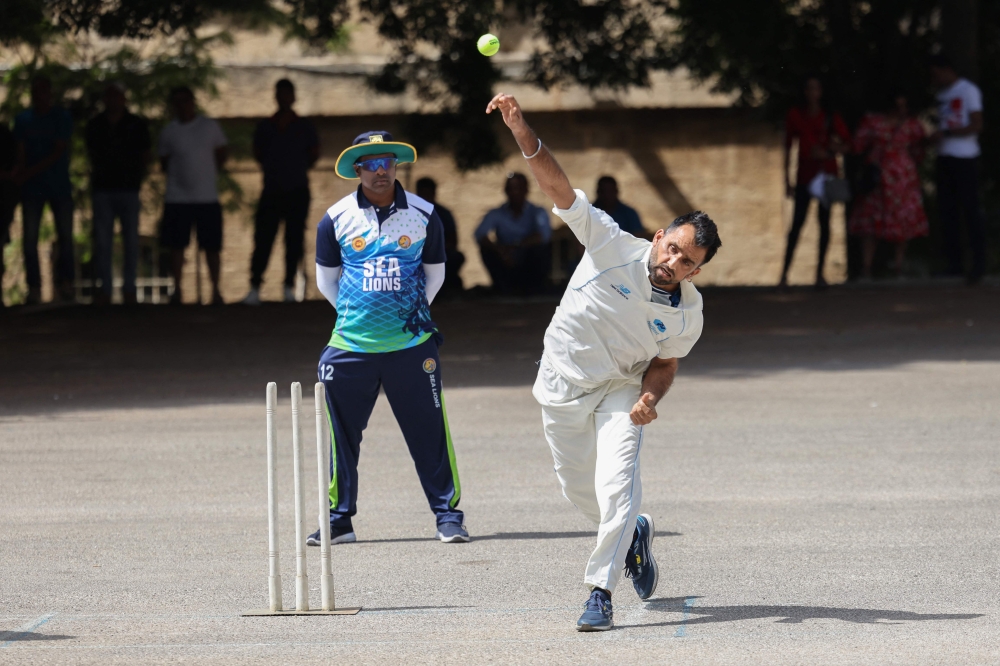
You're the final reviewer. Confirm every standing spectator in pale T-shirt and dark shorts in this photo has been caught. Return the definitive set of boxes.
[159,86,229,305]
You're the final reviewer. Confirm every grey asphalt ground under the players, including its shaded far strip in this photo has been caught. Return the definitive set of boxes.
[0,286,1000,664]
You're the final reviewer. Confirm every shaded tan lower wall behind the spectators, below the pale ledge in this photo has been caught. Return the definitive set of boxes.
[4,109,845,302]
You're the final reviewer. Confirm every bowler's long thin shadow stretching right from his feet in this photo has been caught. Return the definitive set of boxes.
[622,597,983,627]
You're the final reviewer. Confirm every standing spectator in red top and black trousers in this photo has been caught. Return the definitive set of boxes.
[778,77,851,289]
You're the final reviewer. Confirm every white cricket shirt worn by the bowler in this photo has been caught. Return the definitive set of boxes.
[545,190,703,388]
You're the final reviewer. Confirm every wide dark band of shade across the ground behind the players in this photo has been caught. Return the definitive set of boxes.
[0,286,1000,416]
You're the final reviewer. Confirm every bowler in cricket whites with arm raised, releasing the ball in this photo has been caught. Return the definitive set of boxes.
[486,93,722,631]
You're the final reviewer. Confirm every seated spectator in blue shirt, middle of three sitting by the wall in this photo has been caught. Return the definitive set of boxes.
[476,172,552,294]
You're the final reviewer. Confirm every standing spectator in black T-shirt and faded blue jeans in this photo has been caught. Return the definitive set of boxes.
[86,83,151,305]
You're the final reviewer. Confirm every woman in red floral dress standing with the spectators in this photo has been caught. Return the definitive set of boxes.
[848,95,928,279]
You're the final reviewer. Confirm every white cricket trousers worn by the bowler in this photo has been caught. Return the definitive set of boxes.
[532,357,642,592]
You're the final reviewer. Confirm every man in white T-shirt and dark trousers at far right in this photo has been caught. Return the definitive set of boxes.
[931,55,986,284]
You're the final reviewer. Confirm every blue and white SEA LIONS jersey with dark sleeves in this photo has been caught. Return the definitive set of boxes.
[316,181,445,353]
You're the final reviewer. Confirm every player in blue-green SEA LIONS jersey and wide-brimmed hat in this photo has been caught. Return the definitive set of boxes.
[307,131,469,546]
